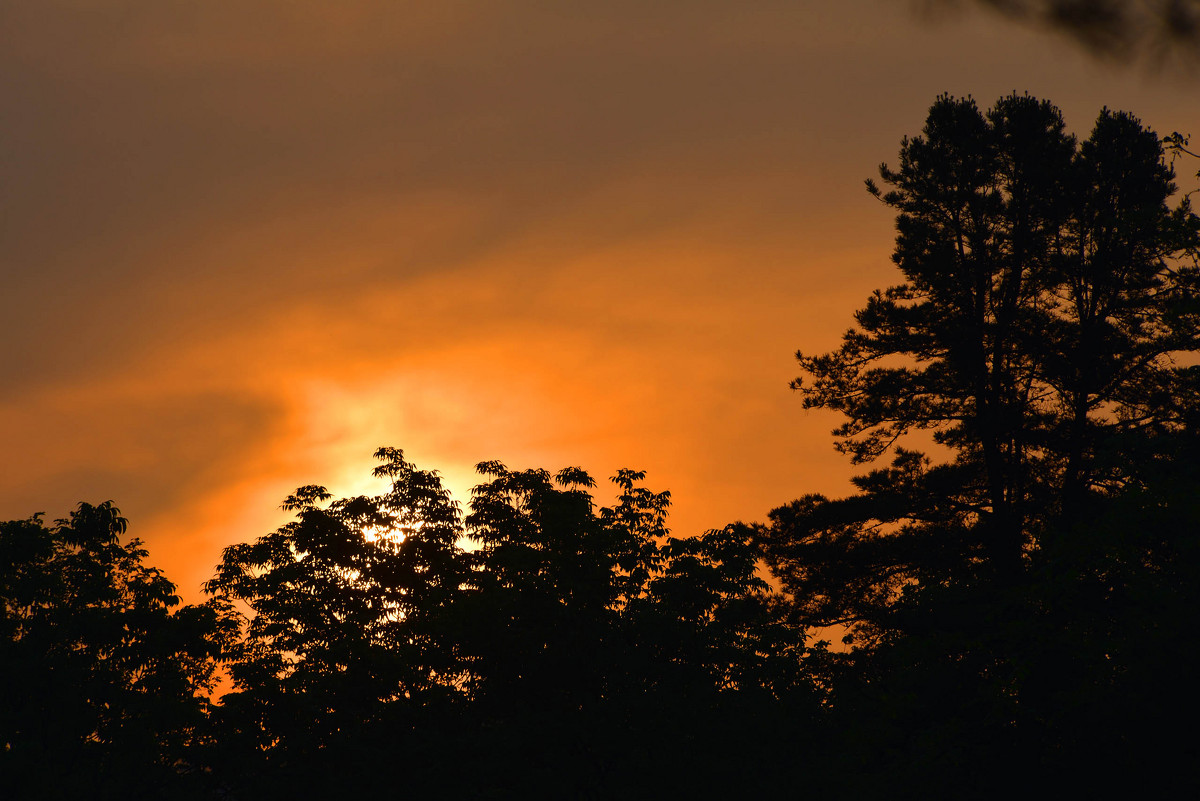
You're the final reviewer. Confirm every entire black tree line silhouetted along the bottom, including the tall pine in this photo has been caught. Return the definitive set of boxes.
[7,95,1200,799]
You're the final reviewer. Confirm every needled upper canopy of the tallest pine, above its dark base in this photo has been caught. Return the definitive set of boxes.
[774,95,1200,625]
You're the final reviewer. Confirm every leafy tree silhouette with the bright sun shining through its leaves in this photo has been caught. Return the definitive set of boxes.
[205,448,469,797]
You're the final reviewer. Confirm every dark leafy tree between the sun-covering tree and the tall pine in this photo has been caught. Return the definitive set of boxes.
[462,463,816,797]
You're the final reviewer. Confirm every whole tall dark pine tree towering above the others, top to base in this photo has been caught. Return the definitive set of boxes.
[761,95,1200,794]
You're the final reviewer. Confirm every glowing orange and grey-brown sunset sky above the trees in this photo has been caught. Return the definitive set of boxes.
[0,0,1200,601]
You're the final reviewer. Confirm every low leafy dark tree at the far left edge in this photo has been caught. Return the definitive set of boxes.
[0,501,236,799]
